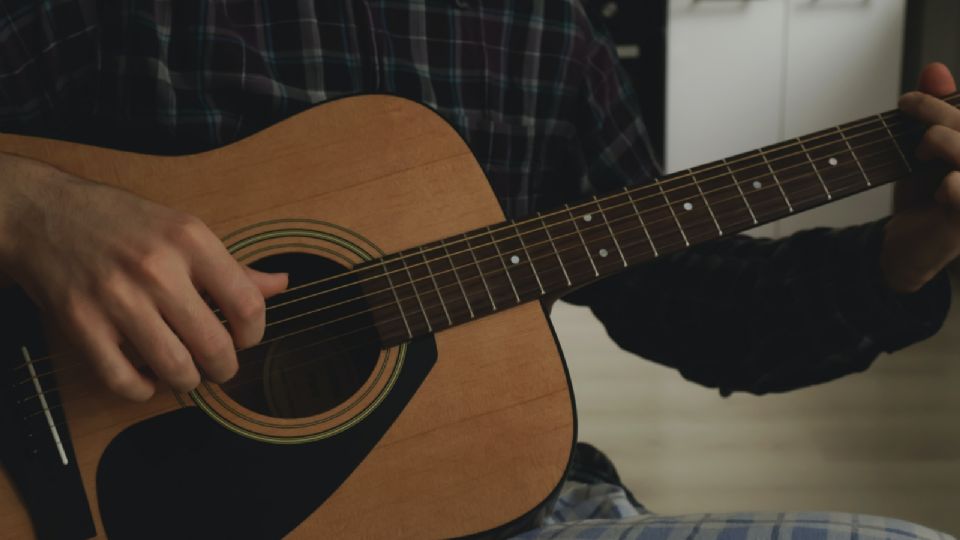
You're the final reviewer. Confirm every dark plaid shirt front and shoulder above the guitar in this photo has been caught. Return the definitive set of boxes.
[0,0,657,216]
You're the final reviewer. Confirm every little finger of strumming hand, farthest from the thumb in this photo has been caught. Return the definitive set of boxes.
[64,309,156,401]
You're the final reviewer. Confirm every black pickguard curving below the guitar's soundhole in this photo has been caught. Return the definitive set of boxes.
[97,337,437,539]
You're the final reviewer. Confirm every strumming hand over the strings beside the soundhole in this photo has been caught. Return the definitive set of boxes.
[0,154,287,400]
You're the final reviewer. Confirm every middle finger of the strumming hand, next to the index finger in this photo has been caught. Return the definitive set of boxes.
[155,277,237,383]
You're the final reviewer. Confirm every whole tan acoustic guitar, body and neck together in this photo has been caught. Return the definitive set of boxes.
[0,95,944,538]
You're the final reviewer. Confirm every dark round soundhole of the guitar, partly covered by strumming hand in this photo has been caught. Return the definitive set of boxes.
[221,253,380,418]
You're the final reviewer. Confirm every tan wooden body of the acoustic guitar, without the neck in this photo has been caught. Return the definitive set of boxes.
[0,96,576,538]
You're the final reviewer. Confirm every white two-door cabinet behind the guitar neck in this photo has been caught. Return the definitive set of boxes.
[666,0,906,236]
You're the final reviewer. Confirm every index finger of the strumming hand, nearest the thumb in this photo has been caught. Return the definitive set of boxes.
[193,244,266,349]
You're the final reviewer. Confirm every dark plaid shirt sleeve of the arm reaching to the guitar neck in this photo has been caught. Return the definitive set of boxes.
[566,4,950,395]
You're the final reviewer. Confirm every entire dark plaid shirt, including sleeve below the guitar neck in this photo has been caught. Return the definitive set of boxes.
[0,0,949,393]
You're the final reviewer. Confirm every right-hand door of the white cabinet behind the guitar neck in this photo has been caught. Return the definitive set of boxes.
[777,0,906,236]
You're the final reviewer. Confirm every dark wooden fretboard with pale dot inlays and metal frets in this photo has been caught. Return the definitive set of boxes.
[361,95,960,345]
